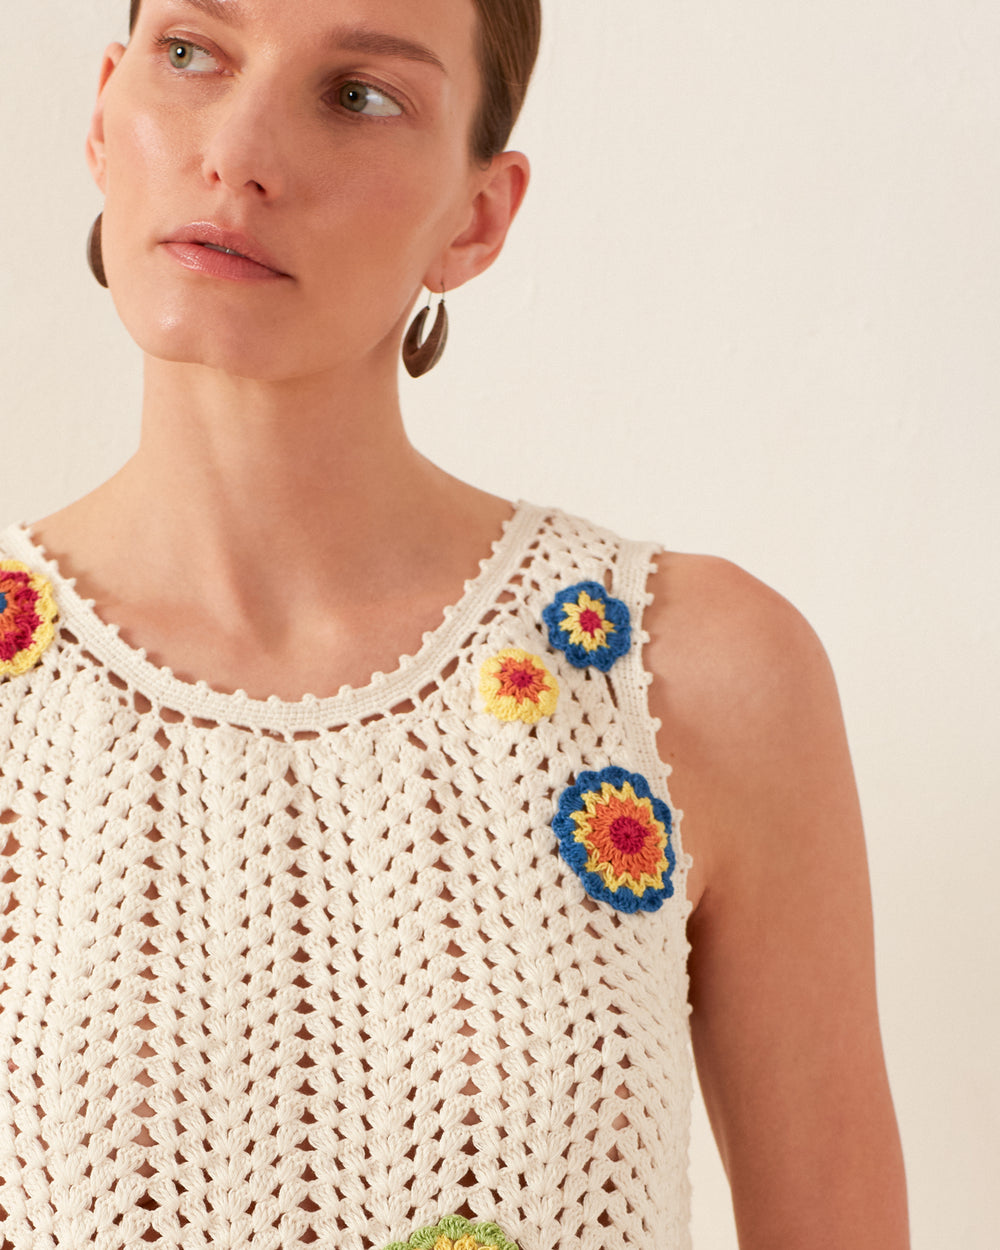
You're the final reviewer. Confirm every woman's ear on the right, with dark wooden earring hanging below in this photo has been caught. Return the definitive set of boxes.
[424,153,531,291]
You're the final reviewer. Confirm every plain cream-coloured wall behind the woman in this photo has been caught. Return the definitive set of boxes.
[0,0,1000,1250]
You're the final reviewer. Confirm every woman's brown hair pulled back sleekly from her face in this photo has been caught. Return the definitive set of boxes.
[129,0,541,164]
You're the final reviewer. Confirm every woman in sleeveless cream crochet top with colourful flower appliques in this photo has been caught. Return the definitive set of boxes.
[0,0,906,1250]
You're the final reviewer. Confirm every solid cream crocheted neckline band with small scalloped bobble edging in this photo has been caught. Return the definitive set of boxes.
[1,500,546,734]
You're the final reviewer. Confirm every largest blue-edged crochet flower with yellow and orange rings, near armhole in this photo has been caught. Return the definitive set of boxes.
[553,768,676,913]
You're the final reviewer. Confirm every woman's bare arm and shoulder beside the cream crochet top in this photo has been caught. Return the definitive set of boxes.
[646,556,909,1250]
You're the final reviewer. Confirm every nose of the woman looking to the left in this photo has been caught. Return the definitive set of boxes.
[201,83,295,199]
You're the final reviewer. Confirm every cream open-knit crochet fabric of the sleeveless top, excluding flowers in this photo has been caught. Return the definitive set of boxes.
[0,504,691,1250]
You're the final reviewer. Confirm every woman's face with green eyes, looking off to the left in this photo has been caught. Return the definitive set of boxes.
[88,0,500,381]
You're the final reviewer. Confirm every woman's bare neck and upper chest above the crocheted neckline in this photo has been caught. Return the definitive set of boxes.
[35,361,510,698]
